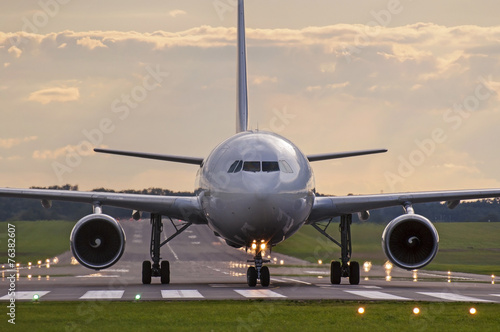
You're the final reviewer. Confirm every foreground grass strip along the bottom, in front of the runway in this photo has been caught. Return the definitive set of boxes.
[6,300,500,332]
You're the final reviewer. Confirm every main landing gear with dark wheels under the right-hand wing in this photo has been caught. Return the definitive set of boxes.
[312,214,359,285]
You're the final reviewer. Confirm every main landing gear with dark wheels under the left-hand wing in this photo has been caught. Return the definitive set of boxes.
[142,213,191,285]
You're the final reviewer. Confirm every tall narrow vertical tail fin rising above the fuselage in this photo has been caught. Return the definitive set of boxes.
[236,0,248,133]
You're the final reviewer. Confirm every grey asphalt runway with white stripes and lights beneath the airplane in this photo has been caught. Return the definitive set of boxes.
[0,220,500,303]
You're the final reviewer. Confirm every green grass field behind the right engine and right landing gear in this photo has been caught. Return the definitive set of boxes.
[274,223,500,275]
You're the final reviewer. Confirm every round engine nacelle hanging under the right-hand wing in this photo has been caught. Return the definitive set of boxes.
[382,214,439,270]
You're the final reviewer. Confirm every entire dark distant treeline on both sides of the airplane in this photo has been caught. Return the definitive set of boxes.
[0,184,500,223]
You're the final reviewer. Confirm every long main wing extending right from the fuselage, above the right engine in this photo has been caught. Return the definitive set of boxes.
[308,189,500,223]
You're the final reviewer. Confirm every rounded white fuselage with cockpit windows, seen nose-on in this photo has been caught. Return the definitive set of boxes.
[196,131,315,247]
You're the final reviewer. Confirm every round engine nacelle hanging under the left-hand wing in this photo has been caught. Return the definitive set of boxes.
[70,214,125,270]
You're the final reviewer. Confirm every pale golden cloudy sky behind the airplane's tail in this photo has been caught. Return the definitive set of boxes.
[0,0,500,195]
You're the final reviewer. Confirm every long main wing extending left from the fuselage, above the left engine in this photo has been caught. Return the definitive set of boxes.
[0,188,207,224]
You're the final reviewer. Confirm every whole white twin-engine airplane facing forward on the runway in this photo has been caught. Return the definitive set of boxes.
[0,0,500,287]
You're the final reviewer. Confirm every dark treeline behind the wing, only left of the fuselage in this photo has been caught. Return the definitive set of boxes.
[0,184,193,221]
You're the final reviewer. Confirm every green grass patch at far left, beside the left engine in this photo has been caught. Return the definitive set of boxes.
[0,220,75,264]
